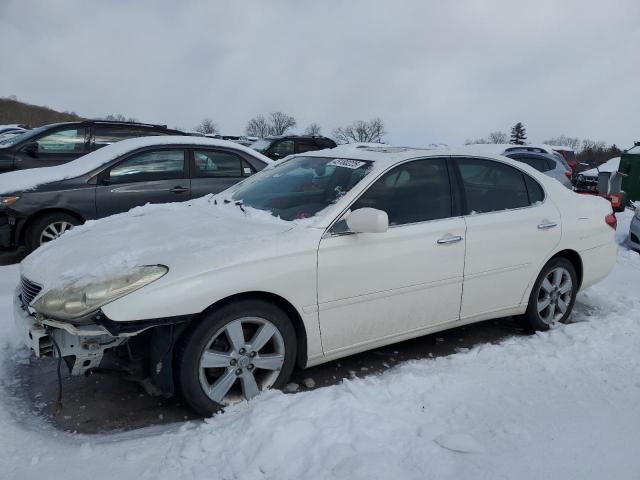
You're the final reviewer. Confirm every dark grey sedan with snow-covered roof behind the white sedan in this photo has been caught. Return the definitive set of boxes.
[0,136,271,251]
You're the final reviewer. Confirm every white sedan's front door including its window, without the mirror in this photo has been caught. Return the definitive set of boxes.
[318,158,465,354]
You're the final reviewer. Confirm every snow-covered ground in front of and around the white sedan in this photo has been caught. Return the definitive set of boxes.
[0,212,640,480]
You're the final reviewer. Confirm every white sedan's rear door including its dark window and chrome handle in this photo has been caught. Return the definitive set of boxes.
[455,157,561,320]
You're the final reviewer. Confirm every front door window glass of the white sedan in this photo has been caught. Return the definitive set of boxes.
[351,158,452,225]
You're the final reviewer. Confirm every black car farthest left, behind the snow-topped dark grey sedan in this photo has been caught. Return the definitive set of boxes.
[0,120,185,172]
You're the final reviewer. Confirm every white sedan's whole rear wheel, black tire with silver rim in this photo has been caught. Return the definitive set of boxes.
[520,257,578,331]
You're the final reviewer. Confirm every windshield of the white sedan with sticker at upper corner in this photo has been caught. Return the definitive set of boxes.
[233,157,372,220]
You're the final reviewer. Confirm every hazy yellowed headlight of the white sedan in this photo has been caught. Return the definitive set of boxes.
[33,265,169,320]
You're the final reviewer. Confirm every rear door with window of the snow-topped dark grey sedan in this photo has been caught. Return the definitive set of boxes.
[191,149,250,198]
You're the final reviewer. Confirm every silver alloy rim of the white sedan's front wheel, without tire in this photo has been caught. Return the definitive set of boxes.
[199,317,285,405]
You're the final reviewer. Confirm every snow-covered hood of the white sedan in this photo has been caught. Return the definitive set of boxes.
[21,197,315,292]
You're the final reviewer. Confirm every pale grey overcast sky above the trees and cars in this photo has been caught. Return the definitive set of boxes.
[0,0,640,147]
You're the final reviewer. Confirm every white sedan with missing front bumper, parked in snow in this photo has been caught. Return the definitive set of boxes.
[14,147,617,414]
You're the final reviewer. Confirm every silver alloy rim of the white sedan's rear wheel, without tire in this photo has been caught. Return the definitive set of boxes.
[537,267,573,325]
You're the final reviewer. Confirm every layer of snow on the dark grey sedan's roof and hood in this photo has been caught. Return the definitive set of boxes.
[0,135,273,195]
